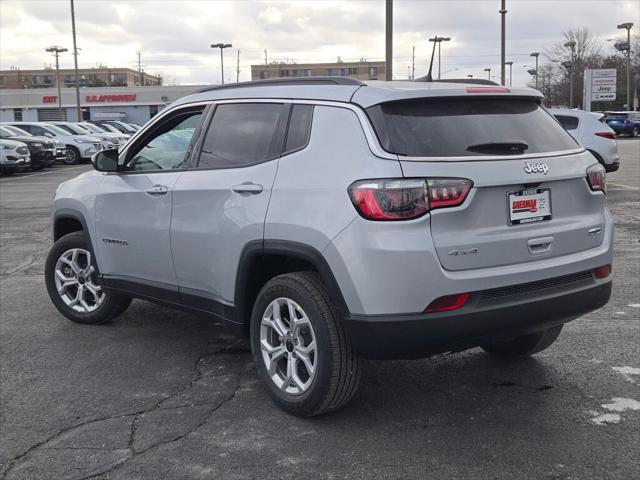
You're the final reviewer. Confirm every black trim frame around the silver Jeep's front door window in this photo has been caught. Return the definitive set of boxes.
[117,102,212,175]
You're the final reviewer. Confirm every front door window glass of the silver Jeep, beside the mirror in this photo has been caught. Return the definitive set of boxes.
[126,108,203,171]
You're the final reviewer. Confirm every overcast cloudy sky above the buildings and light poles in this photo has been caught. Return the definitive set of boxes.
[0,0,640,84]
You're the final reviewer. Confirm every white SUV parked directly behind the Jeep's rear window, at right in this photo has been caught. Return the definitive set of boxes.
[549,108,620,172]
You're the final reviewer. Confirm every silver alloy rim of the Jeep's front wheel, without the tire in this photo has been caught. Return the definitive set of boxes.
[54,248,105,313]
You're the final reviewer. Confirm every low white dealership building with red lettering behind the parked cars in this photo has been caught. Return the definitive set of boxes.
[0,85,205,125]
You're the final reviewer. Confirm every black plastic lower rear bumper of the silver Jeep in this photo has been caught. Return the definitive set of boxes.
[343,272,611,358]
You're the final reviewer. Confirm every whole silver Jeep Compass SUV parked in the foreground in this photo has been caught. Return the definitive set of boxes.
[46,78,613,416]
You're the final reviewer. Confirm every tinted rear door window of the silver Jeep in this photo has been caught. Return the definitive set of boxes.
[198,103,289,168]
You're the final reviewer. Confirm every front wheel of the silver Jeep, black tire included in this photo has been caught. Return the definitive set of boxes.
[45,232,131,324]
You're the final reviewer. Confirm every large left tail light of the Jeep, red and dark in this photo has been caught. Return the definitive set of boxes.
[349,178,473,220]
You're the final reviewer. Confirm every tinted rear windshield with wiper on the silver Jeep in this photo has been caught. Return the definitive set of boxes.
[367,97,577,157]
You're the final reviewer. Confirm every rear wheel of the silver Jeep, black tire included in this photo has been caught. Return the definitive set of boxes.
[251,272,360,417]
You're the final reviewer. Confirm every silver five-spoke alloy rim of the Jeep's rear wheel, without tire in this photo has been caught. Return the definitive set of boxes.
[260,298,318,396]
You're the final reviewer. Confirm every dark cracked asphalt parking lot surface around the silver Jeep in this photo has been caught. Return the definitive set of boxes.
[0,142,640,480]
